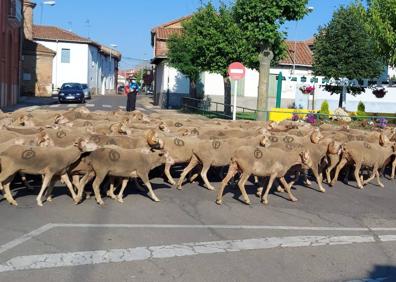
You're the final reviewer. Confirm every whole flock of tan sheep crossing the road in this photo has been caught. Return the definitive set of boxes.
[0,107,396,206]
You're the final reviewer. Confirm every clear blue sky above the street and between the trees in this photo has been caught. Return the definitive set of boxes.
[33,0,354,68]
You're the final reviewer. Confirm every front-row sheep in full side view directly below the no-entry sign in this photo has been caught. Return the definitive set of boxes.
[216,146,312,205]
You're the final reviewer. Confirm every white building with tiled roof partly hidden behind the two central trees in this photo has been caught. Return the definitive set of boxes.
[151,16,313,108]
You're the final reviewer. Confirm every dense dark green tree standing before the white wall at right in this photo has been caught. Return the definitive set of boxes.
[313,2,383,108]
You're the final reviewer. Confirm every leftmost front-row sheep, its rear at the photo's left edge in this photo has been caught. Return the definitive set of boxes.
[0,138,97,206]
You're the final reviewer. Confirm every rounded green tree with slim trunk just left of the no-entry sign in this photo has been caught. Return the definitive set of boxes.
[168,3,245,115]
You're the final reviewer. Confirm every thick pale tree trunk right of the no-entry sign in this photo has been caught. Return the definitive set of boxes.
[257,48,274,120]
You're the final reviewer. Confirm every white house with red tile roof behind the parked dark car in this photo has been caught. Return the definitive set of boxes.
[24,0,121,95]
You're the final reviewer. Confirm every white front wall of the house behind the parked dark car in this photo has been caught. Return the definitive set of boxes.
[37,41,88,89]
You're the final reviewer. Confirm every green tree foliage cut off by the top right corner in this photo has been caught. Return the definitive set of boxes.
[368,0,396,66]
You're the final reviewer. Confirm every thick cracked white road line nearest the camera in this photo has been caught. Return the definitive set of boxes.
[0,235,386,272]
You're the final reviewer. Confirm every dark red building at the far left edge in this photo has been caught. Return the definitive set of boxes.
[0,0,23,107]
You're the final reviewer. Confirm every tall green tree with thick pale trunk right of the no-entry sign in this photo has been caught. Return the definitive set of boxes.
[233,0,308,120]
